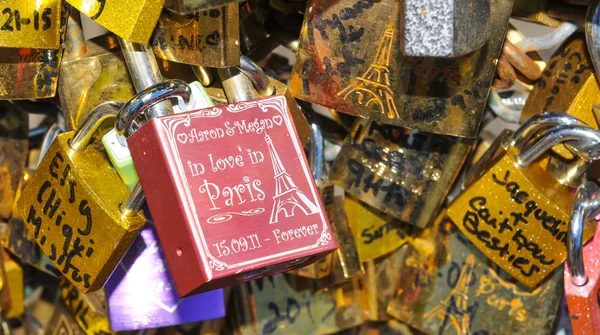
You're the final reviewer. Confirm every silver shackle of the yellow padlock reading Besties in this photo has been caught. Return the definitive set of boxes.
[515,125,600,167]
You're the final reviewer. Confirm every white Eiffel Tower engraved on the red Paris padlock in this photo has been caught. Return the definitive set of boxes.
[265,135,319,224]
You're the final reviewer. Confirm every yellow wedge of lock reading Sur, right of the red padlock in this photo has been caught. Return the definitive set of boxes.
[344,196,414,264]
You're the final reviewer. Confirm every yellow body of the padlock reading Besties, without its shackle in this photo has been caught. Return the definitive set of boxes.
[448,147,596,287]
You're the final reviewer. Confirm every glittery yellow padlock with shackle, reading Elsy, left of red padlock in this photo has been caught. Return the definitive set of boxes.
[17,102,146,293]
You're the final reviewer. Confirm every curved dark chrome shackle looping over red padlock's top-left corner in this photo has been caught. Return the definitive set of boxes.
[115,79,192,138]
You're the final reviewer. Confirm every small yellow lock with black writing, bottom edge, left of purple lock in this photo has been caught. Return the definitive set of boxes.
[59,279,116,335]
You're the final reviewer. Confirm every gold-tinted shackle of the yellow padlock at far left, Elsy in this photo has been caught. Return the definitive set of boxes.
[69,101,124,151]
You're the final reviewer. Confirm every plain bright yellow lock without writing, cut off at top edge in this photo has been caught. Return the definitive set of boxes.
[67,0,164,44]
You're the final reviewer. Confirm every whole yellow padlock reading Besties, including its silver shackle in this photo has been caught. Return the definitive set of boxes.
[448,114,600,287]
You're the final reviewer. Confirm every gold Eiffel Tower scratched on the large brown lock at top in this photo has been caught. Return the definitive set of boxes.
[337,28,399,119]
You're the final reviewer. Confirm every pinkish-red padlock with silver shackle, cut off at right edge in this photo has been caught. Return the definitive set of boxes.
[565,181,600,335]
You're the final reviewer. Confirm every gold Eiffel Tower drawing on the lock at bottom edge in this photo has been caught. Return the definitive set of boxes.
[423,255,477,335]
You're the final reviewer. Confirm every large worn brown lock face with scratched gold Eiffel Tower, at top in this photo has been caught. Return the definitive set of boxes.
[290,0,513,138]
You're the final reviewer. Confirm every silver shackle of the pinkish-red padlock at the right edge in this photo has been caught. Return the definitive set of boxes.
[567,181,600,286]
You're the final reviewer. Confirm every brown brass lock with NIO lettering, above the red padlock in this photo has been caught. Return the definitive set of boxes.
[150,3,240,67]
